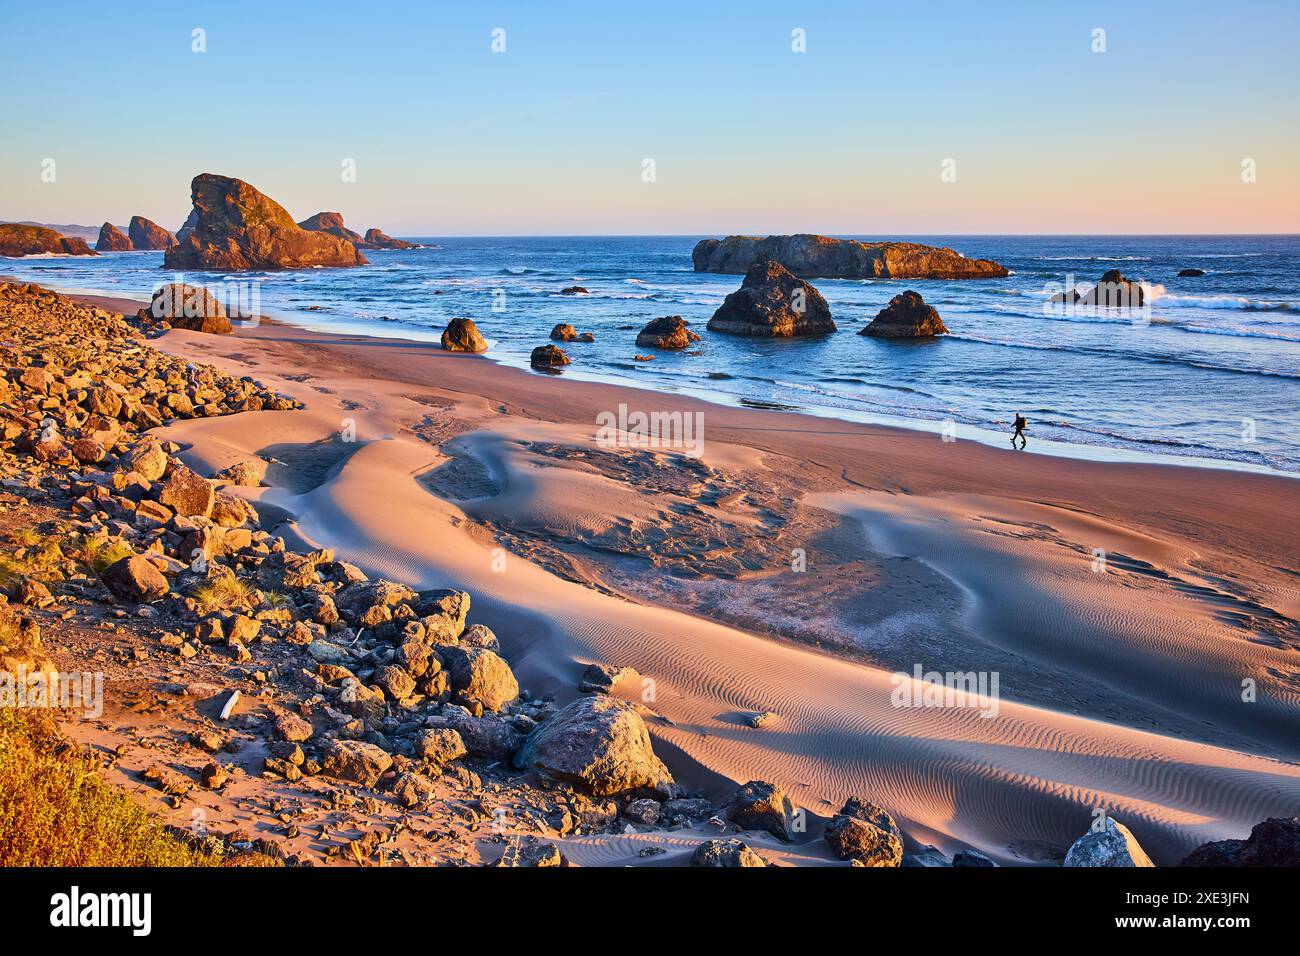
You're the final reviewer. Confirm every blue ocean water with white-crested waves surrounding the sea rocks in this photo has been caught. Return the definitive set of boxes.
[0,235,1300,472]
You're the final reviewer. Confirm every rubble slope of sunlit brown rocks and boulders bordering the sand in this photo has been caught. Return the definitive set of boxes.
[0,284,1300,866]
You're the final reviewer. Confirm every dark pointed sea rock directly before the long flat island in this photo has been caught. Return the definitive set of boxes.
[707,259,835,338]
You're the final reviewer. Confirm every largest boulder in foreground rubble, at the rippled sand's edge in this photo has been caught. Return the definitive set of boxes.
[515,696,672,796]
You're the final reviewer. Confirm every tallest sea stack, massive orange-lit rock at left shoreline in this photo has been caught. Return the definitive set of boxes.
[163,173,365,272]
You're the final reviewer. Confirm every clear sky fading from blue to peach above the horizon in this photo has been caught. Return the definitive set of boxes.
[0,0,1300,237]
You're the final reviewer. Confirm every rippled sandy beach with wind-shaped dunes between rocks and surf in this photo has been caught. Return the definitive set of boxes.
[63,297,1300,864]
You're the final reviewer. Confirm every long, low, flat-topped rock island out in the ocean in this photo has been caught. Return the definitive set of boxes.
[690,233,1008,278]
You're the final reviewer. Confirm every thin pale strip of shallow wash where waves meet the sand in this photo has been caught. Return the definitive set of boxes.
[15,276,1300,480]
